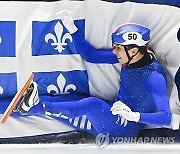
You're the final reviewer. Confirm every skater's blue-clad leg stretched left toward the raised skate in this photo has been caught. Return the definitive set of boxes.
[44,97,124,136]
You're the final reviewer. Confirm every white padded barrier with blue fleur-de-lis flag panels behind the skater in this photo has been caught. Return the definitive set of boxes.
[0,0,180,143]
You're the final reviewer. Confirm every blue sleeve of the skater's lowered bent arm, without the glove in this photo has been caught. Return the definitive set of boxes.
[139,73,171,126]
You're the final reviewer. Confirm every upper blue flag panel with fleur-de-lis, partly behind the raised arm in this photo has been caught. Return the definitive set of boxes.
[32,20,85,56]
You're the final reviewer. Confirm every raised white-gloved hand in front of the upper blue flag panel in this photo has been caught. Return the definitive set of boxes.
[57,10,78,34]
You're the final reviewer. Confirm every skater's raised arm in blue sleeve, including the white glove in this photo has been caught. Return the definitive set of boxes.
[59,10,118,64]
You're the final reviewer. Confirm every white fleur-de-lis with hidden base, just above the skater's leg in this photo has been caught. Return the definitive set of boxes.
[47,74,76,95]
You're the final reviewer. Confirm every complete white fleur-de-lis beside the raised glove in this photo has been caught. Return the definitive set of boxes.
[45,21,72,53]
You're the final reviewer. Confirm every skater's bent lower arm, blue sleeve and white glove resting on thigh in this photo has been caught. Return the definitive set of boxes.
[111,73,171,126]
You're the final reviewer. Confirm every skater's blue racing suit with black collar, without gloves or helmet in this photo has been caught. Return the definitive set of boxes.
[30,31,171,137]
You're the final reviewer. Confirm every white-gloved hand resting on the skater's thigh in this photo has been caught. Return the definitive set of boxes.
[111,101,140,122]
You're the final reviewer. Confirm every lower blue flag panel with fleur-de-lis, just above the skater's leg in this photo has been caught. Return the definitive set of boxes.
[34,71,90,95]
